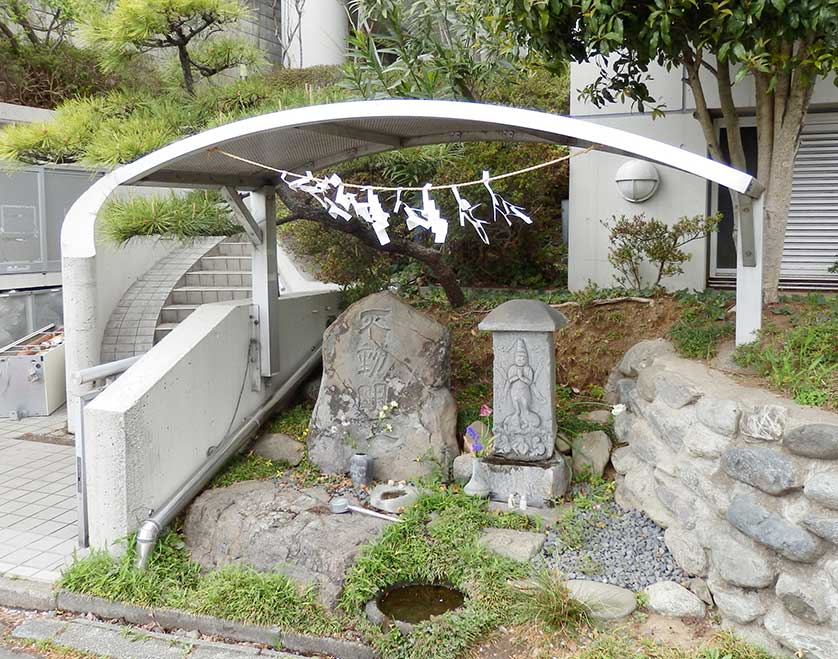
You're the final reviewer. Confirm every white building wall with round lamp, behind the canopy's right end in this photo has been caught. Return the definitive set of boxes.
[568,63,838,290]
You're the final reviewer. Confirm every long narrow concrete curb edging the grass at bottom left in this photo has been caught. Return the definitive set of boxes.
[0,577,378,659]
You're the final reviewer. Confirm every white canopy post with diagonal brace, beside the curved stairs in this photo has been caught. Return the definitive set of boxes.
[248,187,279,378]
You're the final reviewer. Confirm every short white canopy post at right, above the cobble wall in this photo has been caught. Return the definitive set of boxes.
[734,195,765,346]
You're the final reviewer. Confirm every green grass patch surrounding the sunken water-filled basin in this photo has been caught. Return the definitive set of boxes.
[340,488,544,659]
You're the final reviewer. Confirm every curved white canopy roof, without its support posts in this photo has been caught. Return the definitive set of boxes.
[61,100,762,258]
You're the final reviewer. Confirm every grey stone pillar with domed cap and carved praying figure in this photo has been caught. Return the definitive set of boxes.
[478,300,570,506]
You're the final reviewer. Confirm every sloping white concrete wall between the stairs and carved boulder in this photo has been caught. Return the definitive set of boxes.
[85,292,338,548]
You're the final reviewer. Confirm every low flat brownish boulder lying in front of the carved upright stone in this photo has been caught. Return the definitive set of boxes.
[184,481,387,607]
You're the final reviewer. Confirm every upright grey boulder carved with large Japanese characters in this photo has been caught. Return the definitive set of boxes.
[308,293,459,480]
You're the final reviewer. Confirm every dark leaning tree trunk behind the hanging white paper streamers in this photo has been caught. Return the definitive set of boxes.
[277,184,466,308]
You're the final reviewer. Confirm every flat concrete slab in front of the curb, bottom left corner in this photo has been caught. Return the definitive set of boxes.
[12,618,303,659]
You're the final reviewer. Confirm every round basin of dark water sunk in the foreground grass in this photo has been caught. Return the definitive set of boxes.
[366,583,465,633]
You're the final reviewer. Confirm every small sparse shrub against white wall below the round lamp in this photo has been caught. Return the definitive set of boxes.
[602,213,721,294]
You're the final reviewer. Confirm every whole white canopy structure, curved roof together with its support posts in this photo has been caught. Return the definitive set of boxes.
[61,100,763,392]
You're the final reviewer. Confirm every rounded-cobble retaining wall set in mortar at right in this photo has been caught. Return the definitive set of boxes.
[611,340,838,659]
